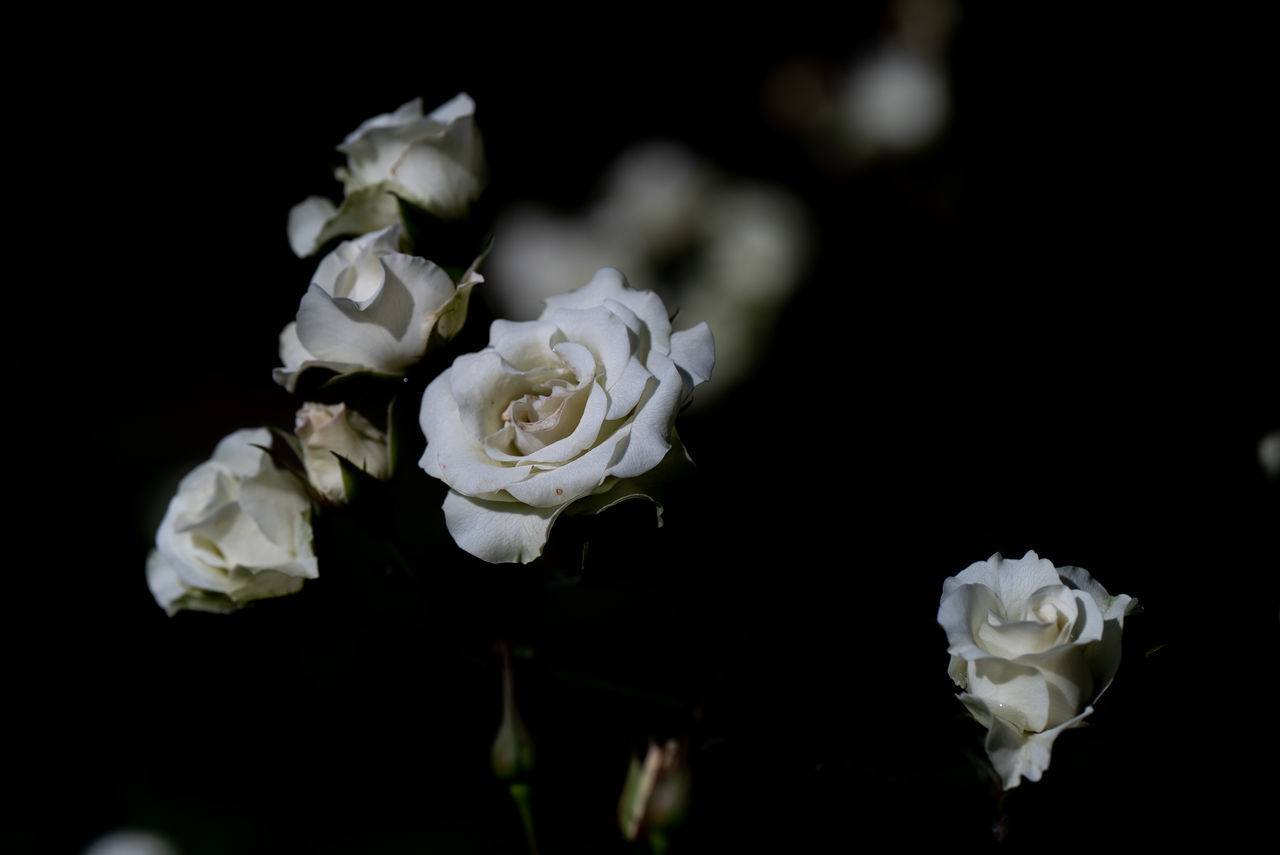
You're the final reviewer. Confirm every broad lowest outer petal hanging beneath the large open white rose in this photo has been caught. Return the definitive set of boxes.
[444,490,564,564]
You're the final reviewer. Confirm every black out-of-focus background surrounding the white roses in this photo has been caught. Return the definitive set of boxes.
[15,4,1280,854]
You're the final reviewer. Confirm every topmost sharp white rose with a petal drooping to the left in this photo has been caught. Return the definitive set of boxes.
[288,93,485,257]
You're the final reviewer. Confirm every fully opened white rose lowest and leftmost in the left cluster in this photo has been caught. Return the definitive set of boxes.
[147,428,317,614]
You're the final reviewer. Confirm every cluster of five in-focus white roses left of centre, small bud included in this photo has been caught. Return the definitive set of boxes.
[147,95,714,614]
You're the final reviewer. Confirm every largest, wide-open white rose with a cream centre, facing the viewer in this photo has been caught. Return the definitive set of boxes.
[421,268,716,563]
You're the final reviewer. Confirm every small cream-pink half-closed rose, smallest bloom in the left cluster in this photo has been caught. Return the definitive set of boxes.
[293,403,392,504]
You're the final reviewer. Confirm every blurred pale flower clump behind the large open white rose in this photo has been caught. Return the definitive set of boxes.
[485,142,810,407]
